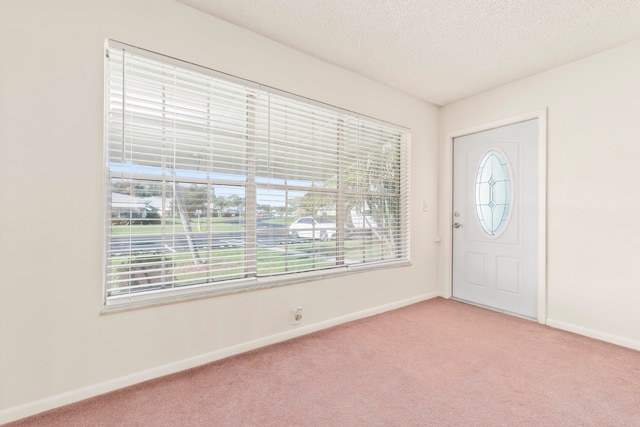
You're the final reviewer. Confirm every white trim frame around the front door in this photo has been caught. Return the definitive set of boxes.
[441,108,547,324]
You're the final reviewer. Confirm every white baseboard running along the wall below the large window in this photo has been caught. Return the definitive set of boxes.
[0,292,438,424]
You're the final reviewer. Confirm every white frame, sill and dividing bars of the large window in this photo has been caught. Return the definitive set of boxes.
[103,40,411,312]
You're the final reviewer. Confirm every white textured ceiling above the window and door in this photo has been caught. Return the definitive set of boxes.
[178,0,640,105]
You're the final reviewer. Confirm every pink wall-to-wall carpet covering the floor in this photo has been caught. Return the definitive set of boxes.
[9,298,640,426]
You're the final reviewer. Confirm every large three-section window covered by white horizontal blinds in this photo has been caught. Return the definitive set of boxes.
[105,42,410,306]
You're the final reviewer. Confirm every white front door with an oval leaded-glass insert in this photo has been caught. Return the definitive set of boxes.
[452,119,539,318]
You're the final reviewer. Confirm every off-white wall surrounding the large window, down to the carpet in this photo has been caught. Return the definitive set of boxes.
[0,0,440,423]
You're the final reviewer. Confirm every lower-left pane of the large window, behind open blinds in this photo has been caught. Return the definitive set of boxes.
[107,179,246,295]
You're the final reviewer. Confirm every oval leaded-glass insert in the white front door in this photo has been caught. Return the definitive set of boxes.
[476,150,511,236]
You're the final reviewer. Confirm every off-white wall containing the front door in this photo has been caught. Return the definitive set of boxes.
[440,41,640,349]
